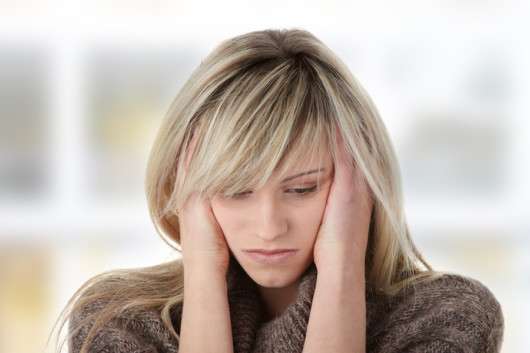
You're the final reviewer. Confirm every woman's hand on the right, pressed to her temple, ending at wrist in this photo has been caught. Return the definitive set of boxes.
[313,139,373,272]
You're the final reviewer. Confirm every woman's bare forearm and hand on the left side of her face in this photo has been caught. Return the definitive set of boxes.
[179,133,234,353]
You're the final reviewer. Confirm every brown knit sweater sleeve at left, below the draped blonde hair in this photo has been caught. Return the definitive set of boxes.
[69,300,178,353]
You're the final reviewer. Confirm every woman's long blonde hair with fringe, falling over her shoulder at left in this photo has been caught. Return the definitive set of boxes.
[54,30,430,346]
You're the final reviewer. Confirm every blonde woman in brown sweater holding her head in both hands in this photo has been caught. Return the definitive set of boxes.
[59,30,503,352]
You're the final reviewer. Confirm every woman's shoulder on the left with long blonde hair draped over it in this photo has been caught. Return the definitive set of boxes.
[68,276,178,353]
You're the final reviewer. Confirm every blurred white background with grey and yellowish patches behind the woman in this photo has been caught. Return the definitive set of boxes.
[0,0,530,353]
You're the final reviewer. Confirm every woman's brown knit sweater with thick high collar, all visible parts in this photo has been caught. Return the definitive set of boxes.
[69,266,503,353]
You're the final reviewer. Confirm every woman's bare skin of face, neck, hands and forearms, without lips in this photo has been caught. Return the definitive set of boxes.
[179,133,372,352]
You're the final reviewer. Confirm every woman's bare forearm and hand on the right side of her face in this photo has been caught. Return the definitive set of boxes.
[304,138,372,352]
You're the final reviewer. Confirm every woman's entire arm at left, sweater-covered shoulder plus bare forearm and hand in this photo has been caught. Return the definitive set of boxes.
[68,192,233,353]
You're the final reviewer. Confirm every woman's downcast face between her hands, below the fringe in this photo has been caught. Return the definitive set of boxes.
[211,148,333,288]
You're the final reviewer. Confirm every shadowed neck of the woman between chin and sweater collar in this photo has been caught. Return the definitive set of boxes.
[258,280,300,321]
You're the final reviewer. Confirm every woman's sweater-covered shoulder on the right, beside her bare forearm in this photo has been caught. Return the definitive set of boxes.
[367,274,504,352]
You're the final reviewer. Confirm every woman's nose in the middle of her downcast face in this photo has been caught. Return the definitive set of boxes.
[255,197,289,242]
